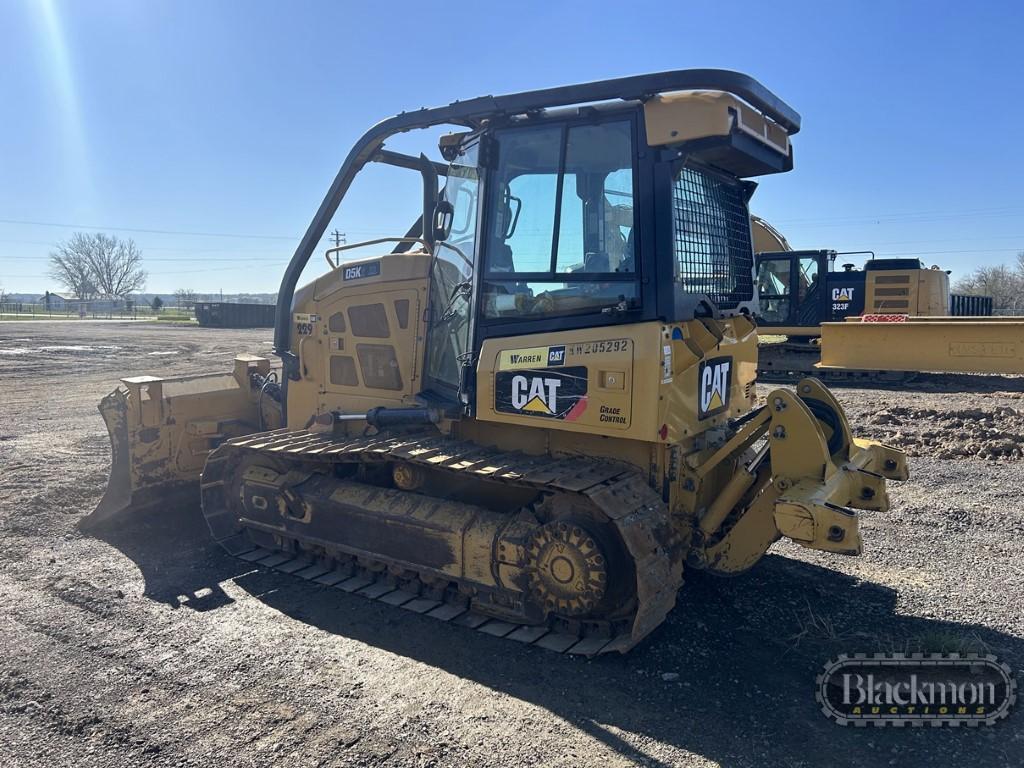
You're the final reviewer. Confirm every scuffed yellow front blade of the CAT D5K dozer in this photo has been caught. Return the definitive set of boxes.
[82,355,281,527]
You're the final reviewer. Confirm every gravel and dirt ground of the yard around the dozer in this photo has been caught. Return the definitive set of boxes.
[0,322,1024,768]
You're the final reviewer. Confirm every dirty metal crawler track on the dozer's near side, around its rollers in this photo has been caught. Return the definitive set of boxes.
[202,430,682,656]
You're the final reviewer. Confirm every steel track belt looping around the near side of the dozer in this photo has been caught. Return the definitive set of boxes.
[201,429,683,655]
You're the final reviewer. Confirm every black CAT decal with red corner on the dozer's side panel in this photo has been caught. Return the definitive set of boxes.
[495,366,587,421]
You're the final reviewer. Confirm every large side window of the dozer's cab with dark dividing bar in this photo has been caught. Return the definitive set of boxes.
[483,120,639,318]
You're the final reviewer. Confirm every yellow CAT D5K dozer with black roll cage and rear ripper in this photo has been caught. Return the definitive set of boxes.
[86,70,907,654]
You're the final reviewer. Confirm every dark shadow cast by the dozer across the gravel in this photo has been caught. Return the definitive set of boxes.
[91,504,1024,768]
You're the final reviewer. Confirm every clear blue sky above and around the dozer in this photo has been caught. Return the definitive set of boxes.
[0,0,1024,293]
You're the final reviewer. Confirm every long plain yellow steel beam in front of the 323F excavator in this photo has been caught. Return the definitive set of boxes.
[818,316,1024,374]
